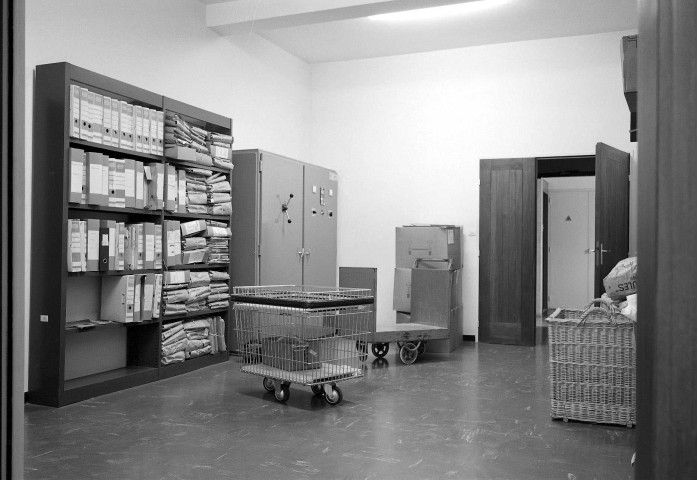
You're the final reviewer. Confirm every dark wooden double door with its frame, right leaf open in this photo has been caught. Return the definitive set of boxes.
[479,143,629,345]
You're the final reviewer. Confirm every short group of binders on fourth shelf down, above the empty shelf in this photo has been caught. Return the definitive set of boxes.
[100,273,162,323]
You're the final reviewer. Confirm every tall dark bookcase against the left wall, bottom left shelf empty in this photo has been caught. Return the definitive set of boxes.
[27,62,232,407]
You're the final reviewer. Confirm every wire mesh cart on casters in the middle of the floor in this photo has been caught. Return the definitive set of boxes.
[230,285,373,405]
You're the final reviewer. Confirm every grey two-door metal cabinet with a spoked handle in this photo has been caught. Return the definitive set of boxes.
[230,150,338,286]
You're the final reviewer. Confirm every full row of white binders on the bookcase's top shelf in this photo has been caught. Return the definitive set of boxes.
[70,85,164,155]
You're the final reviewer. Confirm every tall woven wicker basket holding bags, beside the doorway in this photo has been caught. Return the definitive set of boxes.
[547,300,636,427]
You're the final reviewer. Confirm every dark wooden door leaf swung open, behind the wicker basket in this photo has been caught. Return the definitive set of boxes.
[594,143,629,298]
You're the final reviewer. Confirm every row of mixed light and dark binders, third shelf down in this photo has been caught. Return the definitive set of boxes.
[67,218,162,272]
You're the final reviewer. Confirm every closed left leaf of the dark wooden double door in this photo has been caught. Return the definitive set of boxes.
[479,158,537,345]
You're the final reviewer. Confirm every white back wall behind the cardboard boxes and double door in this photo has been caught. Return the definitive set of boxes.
[311,32,635,335]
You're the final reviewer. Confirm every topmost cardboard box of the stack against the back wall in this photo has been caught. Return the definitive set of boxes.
[395,225,462,270]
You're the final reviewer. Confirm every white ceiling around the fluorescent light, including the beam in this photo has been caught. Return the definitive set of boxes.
[199,0,638,63]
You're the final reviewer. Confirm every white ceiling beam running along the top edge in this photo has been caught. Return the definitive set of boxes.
[204,0,479,35]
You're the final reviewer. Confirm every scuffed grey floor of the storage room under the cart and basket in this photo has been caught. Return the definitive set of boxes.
[24,343,635,480]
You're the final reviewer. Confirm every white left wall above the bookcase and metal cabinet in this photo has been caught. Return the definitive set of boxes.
[21,0,311,386]
